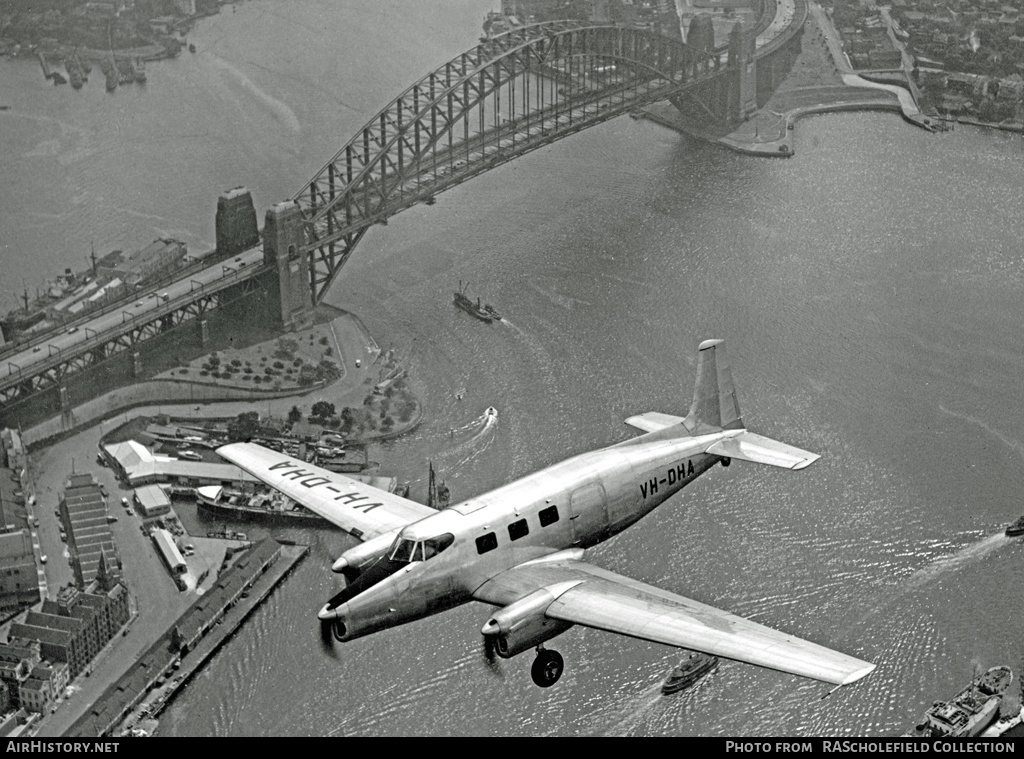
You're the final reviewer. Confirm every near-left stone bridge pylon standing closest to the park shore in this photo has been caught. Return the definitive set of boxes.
[263,201,313,332]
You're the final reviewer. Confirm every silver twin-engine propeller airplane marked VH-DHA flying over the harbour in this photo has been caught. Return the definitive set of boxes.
[217,340,874,687]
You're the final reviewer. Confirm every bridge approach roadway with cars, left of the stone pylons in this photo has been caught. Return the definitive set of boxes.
[0,246,266,404]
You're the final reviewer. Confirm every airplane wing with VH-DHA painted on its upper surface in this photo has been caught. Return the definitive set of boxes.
[217,442,437,541]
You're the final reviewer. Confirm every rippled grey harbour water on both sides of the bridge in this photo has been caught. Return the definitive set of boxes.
[0,0,1024,735]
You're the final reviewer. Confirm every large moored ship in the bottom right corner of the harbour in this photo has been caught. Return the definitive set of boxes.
[906,667,1014,737]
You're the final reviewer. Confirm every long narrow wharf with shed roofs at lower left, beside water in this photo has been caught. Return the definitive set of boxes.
[58,544,309,737]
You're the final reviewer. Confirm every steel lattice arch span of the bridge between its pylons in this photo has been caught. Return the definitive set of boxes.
[293,22,729,303]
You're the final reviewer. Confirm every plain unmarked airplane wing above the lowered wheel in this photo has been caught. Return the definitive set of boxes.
[473,549,874,685]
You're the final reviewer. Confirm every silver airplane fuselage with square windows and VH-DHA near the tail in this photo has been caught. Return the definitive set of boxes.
[321,430,727,640]
